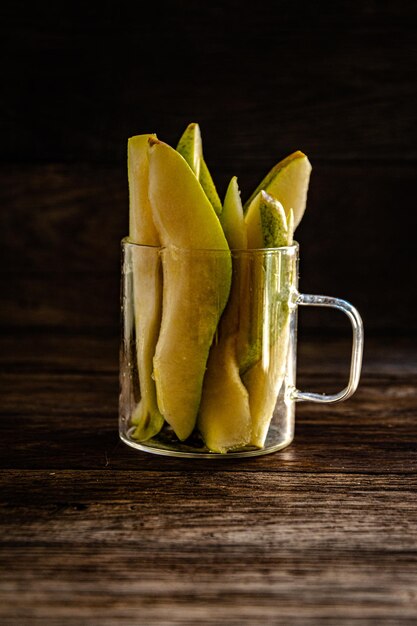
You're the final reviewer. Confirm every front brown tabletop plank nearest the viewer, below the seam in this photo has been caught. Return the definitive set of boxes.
[0,470,417,625]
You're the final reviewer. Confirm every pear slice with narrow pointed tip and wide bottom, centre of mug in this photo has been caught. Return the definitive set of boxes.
[197,177,252,453]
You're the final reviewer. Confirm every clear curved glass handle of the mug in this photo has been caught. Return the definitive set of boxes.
[292,294,363,403]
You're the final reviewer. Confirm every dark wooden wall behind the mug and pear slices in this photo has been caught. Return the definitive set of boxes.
[0,0,417,334]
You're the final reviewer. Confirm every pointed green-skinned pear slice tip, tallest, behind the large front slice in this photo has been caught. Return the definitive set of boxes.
[177,122,222,215]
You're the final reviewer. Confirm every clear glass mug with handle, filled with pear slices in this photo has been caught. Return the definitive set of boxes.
[119,239,363,459]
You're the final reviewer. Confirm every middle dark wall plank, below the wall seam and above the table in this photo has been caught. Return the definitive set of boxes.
[0,163,417,332]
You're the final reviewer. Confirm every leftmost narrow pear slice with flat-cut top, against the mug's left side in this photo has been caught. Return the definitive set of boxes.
[128,135,164,441]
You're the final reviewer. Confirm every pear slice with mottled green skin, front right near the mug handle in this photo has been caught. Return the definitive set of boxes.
[238,190,295,448]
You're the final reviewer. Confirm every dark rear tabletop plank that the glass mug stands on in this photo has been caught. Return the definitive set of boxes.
[0,335,417,474]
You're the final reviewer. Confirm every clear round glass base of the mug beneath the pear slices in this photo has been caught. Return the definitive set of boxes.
[120,426,293,460]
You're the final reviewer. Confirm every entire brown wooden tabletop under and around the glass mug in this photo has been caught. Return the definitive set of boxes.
[0,329,417,626]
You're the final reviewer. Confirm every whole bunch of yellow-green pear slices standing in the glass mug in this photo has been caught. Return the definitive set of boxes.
[128,123,311,454]
